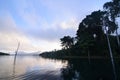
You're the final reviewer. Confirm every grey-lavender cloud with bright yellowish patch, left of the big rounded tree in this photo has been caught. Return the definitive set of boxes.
[20,18,79,42]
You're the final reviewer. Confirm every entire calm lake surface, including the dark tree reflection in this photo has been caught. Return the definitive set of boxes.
[0,56,120,80]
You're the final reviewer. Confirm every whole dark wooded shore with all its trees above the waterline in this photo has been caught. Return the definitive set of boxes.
[40,0,120,58]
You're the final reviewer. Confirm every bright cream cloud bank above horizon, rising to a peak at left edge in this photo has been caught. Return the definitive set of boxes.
[0,12,61,52]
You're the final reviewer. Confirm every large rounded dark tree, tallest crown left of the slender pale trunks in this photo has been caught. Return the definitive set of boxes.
[77,10,105,55]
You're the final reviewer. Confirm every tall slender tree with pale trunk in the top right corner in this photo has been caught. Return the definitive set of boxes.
[103,0,120,48]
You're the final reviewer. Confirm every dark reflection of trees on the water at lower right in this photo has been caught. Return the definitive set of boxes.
[61,59,120,80]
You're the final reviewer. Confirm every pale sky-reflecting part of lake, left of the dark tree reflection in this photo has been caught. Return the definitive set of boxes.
[0,56,67,80]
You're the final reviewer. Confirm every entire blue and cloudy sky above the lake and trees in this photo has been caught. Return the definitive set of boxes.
[0,0,113,52]
